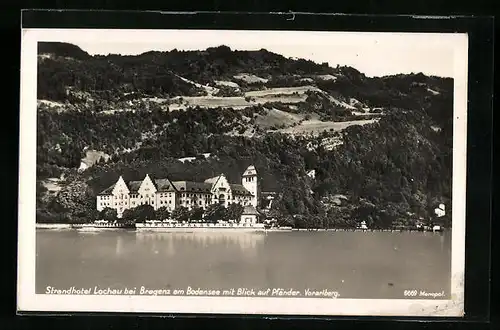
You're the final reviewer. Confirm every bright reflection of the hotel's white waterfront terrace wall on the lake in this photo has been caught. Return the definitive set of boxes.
[136,231,266,256]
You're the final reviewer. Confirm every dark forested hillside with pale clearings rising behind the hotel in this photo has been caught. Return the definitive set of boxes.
[37,43,453,228]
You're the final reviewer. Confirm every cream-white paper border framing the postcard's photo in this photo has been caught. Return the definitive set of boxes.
[17,29,468,316]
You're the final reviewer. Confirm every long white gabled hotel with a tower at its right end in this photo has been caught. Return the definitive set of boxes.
[97,165,260,217]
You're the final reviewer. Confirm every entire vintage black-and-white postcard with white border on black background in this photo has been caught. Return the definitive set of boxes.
[18,29,468,316]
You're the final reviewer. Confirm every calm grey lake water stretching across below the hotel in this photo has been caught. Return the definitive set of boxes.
[36,229,451,299]
